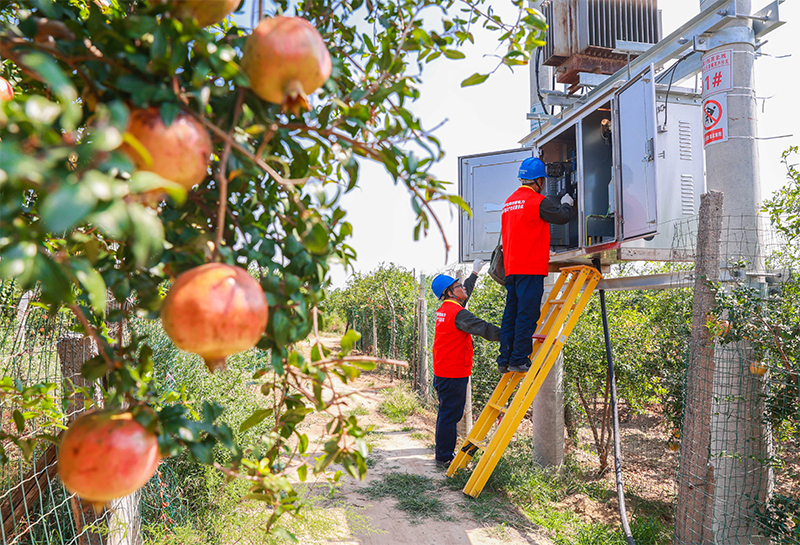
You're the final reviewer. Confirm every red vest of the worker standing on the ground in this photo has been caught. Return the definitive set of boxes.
[433,299,472,378]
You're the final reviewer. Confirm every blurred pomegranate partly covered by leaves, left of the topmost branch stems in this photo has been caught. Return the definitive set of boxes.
[122,108,211,189]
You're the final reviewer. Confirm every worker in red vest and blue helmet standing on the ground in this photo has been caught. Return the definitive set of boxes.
[431,259,500,467]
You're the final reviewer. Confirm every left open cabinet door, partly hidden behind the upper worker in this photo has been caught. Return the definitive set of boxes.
[458,148,532,263]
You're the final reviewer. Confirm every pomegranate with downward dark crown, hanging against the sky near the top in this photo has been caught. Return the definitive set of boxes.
[242,16,332,115]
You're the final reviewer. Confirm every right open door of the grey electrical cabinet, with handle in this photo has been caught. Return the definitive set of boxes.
[616,66,659,240]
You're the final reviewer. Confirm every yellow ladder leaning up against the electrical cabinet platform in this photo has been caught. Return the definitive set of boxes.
[447,266,602,498]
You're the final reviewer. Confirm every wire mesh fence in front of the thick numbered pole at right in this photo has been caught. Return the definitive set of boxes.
[675,207,800,544]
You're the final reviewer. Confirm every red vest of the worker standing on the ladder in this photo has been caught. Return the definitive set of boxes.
[502,185,550,276]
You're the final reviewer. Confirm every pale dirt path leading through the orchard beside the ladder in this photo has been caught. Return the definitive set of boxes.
[294,332,552,545]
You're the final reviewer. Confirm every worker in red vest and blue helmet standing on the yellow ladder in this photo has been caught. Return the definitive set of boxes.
[497,157,575,373]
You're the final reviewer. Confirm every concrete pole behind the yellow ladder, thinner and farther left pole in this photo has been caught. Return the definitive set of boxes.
[530,0,564,467]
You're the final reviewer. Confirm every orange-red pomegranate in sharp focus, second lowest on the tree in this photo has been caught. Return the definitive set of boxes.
[161,263,269,372]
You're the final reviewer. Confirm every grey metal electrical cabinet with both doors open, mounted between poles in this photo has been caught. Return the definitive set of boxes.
[459,67,705,267]
